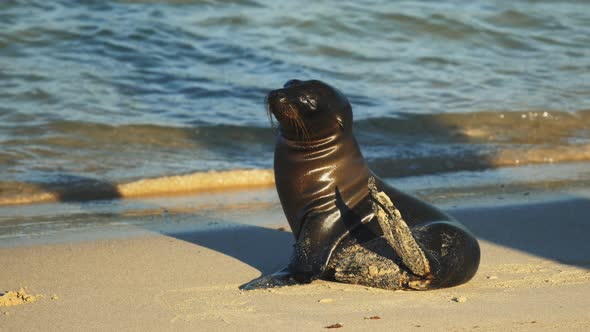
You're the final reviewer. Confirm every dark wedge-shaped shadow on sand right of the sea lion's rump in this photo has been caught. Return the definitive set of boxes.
[449,197,590,269]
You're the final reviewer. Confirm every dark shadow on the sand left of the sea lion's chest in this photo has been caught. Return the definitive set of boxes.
[166,225,295,275]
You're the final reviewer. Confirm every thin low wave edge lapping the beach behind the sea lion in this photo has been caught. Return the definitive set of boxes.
[0,159,590,209]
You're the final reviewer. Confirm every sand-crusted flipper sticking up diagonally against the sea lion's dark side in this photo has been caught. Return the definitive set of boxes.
[368,176,432,279]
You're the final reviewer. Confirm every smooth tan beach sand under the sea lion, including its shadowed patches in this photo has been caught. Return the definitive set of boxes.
[0,198,590,331]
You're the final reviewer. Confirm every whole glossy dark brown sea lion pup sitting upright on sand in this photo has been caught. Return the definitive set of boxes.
[243,80,480,290]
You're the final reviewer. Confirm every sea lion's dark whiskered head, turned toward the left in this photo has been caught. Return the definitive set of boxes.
[266,80,352,142]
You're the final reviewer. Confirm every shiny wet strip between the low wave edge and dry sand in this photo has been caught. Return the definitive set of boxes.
[0,163,590,248]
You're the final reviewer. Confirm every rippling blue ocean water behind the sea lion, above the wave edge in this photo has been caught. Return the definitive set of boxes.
[0,0,590,204]
